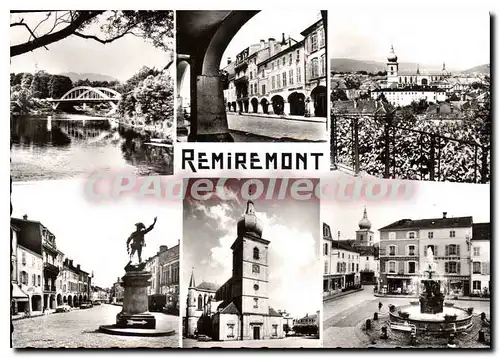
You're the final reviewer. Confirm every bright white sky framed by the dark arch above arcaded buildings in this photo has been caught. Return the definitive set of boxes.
[221,8,321,68]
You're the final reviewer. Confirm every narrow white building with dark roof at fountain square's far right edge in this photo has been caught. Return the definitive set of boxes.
[470,223,491,296]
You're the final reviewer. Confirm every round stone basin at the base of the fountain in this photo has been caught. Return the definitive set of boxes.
[389,305,472,334]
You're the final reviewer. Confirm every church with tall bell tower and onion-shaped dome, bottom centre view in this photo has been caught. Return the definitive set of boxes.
[184,201,285,341]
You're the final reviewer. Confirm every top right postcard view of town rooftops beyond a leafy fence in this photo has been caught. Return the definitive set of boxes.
[329,7,491,183]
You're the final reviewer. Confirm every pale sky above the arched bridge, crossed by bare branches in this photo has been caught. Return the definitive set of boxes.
[9,13,172,82]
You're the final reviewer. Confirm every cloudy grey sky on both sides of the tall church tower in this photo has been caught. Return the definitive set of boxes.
[181,181,321,317]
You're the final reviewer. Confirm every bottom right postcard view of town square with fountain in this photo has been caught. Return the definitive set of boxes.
[321,174,493,349]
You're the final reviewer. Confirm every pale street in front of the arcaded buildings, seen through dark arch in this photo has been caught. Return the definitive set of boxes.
[227,113,328,142]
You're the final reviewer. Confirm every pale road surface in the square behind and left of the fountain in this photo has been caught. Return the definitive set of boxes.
[323,286,490,348]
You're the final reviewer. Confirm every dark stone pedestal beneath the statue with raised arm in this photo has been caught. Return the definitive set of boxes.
[116,268,156,329]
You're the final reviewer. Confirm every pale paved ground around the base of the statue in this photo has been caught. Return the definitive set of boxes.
[12,304,179,348]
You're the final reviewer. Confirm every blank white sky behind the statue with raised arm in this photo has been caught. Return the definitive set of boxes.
[12,180,182,287]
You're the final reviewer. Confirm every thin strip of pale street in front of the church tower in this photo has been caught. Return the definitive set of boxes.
[182,337,321,348]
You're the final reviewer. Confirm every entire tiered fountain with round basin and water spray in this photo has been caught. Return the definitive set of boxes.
[389,247,472,334]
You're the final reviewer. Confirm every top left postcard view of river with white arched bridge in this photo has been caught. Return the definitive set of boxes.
[10,11,174,181]
